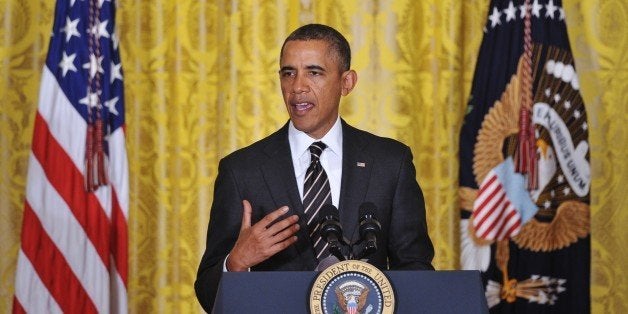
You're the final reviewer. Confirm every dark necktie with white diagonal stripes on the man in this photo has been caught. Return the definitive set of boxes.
[303,142,331,260]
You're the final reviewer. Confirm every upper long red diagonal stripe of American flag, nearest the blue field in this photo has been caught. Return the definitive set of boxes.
[33,114,110,267]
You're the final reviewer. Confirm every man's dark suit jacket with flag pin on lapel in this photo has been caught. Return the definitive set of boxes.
[194,121,434,312]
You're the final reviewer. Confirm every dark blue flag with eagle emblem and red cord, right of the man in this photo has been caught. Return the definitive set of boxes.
[459,0,591,313]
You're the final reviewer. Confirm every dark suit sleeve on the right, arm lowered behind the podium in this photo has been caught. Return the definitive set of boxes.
[388,146,434,270]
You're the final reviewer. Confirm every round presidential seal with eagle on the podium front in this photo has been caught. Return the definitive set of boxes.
[310,260,395,314]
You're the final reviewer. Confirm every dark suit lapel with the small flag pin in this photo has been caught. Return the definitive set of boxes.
[338,120,373,242]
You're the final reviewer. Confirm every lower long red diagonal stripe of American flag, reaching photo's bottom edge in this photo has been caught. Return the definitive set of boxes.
[22,202,97,313]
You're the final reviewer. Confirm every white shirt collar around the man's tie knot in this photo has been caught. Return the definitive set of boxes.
[288,116,342,158]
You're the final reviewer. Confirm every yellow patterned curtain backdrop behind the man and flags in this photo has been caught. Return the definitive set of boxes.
[0,0,628,313]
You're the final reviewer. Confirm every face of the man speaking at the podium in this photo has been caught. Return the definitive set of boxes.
[279,40,355,139]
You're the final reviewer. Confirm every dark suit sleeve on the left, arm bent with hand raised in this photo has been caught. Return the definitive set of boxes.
[194,160,243,313]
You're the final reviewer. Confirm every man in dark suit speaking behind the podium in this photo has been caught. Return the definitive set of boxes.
[195,24,434,312]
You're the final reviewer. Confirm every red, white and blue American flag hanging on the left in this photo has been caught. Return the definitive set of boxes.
[13,0,129,313]
